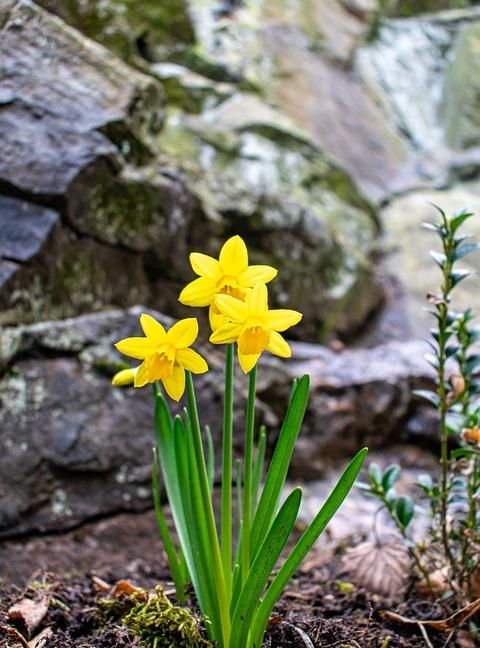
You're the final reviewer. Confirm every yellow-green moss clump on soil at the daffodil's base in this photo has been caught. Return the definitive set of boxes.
[122,586,212,648]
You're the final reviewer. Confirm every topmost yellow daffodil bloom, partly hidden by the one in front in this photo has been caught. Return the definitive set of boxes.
[179,236,277,330]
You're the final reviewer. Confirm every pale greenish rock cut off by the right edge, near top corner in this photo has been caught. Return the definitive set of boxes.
[441,21,480,149]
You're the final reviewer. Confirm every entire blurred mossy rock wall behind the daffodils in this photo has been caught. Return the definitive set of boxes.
[0,0,480,576]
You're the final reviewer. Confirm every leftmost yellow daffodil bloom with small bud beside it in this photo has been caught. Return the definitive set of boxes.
[114,313,208,401]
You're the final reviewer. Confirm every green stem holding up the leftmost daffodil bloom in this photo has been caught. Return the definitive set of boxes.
[185,371,230,648]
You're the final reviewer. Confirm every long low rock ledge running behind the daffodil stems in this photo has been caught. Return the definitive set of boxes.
[0,308,430,537]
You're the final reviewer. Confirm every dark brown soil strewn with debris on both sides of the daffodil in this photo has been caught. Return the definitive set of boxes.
[0,513,478,648]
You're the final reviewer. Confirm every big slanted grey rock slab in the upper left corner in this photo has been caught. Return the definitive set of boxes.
[0,1,162,197]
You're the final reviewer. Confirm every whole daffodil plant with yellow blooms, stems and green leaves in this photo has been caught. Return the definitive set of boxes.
[113,236,367,648]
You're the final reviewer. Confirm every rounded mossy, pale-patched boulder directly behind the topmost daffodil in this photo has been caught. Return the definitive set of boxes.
[160,93,383,340]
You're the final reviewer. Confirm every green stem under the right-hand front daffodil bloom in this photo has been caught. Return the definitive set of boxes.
[242,365,257,582]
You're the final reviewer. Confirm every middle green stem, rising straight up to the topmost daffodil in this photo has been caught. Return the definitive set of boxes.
[221,344,234,599]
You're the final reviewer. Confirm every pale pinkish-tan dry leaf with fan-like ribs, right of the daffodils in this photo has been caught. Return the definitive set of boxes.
[342,540,412,599]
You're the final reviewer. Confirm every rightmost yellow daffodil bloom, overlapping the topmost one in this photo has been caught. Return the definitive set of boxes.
[210,283,302,373]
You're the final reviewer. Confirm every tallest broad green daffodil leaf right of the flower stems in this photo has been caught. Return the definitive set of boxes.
[250,375,310,558]
